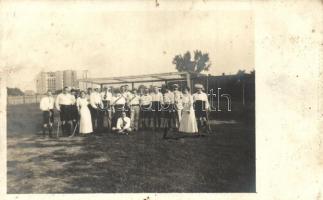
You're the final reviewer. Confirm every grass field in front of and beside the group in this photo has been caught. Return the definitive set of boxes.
[7,104,255,193]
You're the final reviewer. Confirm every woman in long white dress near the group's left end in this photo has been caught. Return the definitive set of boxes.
[76,91,93,134]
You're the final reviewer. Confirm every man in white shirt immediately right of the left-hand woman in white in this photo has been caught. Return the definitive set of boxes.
[89,87,102,133]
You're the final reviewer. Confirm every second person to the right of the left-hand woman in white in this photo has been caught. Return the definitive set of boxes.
[100,87,112,130]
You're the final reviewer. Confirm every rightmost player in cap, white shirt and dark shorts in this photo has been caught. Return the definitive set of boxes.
[193,84,210,132]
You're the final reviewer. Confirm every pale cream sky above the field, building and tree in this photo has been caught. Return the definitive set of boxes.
[0,1,255,90]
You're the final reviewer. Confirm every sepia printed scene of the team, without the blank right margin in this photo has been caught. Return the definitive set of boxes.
[1,1,257,194]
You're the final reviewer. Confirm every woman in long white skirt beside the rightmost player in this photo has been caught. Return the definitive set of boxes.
[179,87,198,133]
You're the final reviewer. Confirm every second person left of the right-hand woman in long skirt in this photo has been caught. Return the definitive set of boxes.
[162,87,176,139]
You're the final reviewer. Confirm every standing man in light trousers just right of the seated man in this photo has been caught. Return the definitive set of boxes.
[128,89,140,131]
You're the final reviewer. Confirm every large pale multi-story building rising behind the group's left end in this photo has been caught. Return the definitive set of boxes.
[36,70,87,94]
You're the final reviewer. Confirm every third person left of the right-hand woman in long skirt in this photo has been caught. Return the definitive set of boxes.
[150,86,163,130]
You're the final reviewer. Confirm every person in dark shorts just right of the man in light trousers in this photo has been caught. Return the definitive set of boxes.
[140,87,152,129]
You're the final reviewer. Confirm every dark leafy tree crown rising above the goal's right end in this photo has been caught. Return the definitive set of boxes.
[172,50,211,73]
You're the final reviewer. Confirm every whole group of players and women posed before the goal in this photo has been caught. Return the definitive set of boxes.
[40,84,210,138]
